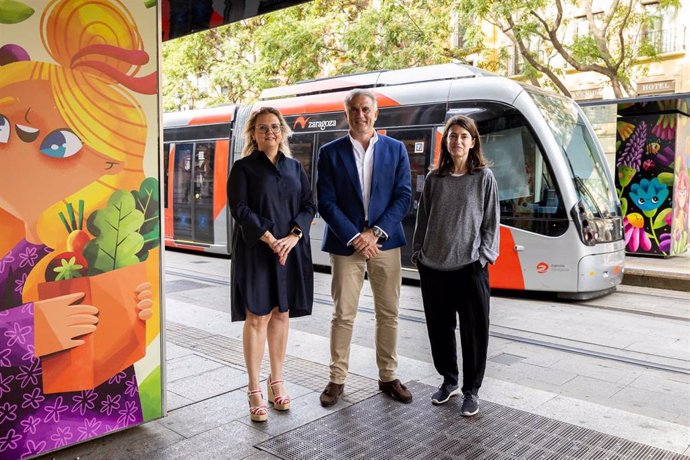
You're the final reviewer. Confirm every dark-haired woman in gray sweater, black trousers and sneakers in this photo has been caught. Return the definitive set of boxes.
[412,115,499,416]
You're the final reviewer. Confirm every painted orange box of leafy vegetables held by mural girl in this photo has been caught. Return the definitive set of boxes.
[39,179,159,393]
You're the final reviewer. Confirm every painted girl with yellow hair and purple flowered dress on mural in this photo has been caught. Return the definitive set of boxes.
[0,0,157,459]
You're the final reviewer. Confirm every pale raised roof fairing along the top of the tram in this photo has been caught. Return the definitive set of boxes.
[259,64,496,100]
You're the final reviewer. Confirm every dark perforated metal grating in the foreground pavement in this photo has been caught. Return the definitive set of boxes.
[256,382,690,460]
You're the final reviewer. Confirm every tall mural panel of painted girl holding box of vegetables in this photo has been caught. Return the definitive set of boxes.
[0,0,162,459]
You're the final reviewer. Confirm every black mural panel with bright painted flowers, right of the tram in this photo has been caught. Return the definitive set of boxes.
[616,98,688,256]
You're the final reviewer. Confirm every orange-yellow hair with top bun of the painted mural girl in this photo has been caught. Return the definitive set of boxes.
[0,0,157,297]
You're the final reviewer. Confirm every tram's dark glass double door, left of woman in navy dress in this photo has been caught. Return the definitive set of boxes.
[172,142,215,244]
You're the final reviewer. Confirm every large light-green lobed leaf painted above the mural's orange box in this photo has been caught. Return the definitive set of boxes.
[84,190,144,275]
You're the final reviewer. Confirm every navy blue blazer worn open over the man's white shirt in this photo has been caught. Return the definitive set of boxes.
[316,134,412,256]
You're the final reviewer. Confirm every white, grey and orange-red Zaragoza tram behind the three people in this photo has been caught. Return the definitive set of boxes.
[163,64,625,298]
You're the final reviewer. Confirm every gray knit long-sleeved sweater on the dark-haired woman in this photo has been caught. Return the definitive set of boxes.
[412,168,500,270]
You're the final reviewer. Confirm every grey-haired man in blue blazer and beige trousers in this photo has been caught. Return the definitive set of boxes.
[316,89,412,407]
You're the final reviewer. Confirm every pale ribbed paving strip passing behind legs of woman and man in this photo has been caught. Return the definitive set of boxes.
[166,321,379,403]
